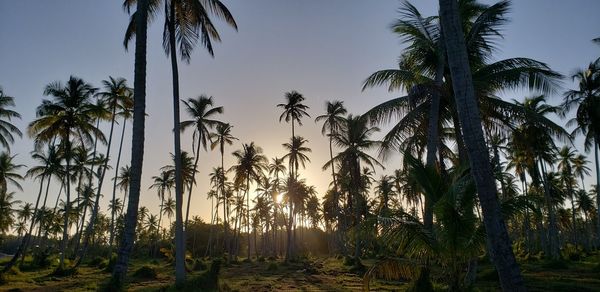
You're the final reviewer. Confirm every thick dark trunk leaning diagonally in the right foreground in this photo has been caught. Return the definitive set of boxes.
[439,0,526,291]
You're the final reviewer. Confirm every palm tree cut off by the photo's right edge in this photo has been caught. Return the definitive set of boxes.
[561,59,600,242]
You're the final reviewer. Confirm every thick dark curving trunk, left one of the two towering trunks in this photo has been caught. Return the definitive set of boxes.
[112,0,148,287]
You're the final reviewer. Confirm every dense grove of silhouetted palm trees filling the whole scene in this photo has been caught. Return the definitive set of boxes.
[0,0,600,291]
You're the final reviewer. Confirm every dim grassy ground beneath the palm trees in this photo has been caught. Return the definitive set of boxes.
[0,254,600,292]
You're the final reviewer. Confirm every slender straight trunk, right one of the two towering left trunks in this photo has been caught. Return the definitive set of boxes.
[167,1,185,286]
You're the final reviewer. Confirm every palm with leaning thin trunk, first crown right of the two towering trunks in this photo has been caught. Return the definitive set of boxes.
[181,95,223,228]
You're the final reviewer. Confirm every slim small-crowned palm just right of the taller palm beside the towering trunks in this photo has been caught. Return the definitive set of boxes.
[209,123,237,260]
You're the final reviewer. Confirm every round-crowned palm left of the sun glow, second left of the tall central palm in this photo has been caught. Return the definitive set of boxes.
[229,142,267,259]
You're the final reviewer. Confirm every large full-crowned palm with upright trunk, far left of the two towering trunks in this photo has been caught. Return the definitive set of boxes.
[28,76,106,269]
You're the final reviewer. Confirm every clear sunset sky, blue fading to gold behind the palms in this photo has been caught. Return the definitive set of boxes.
[0,0,600,225]
